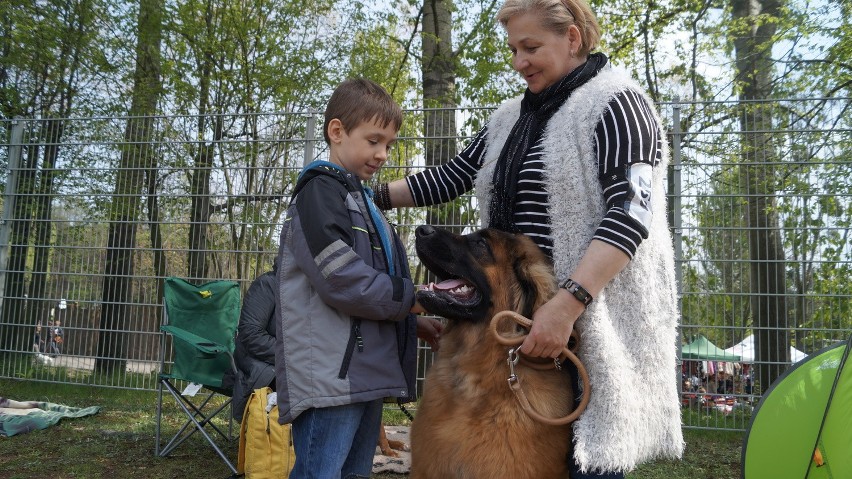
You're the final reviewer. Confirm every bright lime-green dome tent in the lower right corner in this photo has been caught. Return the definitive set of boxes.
[742,337,852,479]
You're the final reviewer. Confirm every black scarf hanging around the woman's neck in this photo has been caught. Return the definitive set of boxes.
[488,53,607,233]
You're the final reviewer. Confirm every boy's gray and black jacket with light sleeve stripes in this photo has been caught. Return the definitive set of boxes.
[275,162,417,424]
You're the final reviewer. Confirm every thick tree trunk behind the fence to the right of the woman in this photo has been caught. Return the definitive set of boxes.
[732,0,790,391]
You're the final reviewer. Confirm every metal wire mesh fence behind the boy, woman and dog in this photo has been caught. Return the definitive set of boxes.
[0,98,852,429]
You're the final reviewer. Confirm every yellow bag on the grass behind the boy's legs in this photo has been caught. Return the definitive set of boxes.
[237,387,296,479]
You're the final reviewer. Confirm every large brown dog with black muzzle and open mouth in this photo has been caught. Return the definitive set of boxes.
[411,226,573,479]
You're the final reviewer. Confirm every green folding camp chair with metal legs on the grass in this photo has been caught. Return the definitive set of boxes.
[155,278,240,475]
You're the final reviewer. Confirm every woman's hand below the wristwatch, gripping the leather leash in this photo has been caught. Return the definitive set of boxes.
[521,289,585,358]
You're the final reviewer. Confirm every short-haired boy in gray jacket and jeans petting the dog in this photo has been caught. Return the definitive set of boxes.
[275,79,440,479]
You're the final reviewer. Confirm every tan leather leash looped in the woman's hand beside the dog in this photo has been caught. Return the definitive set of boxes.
[490,311,592,426]
